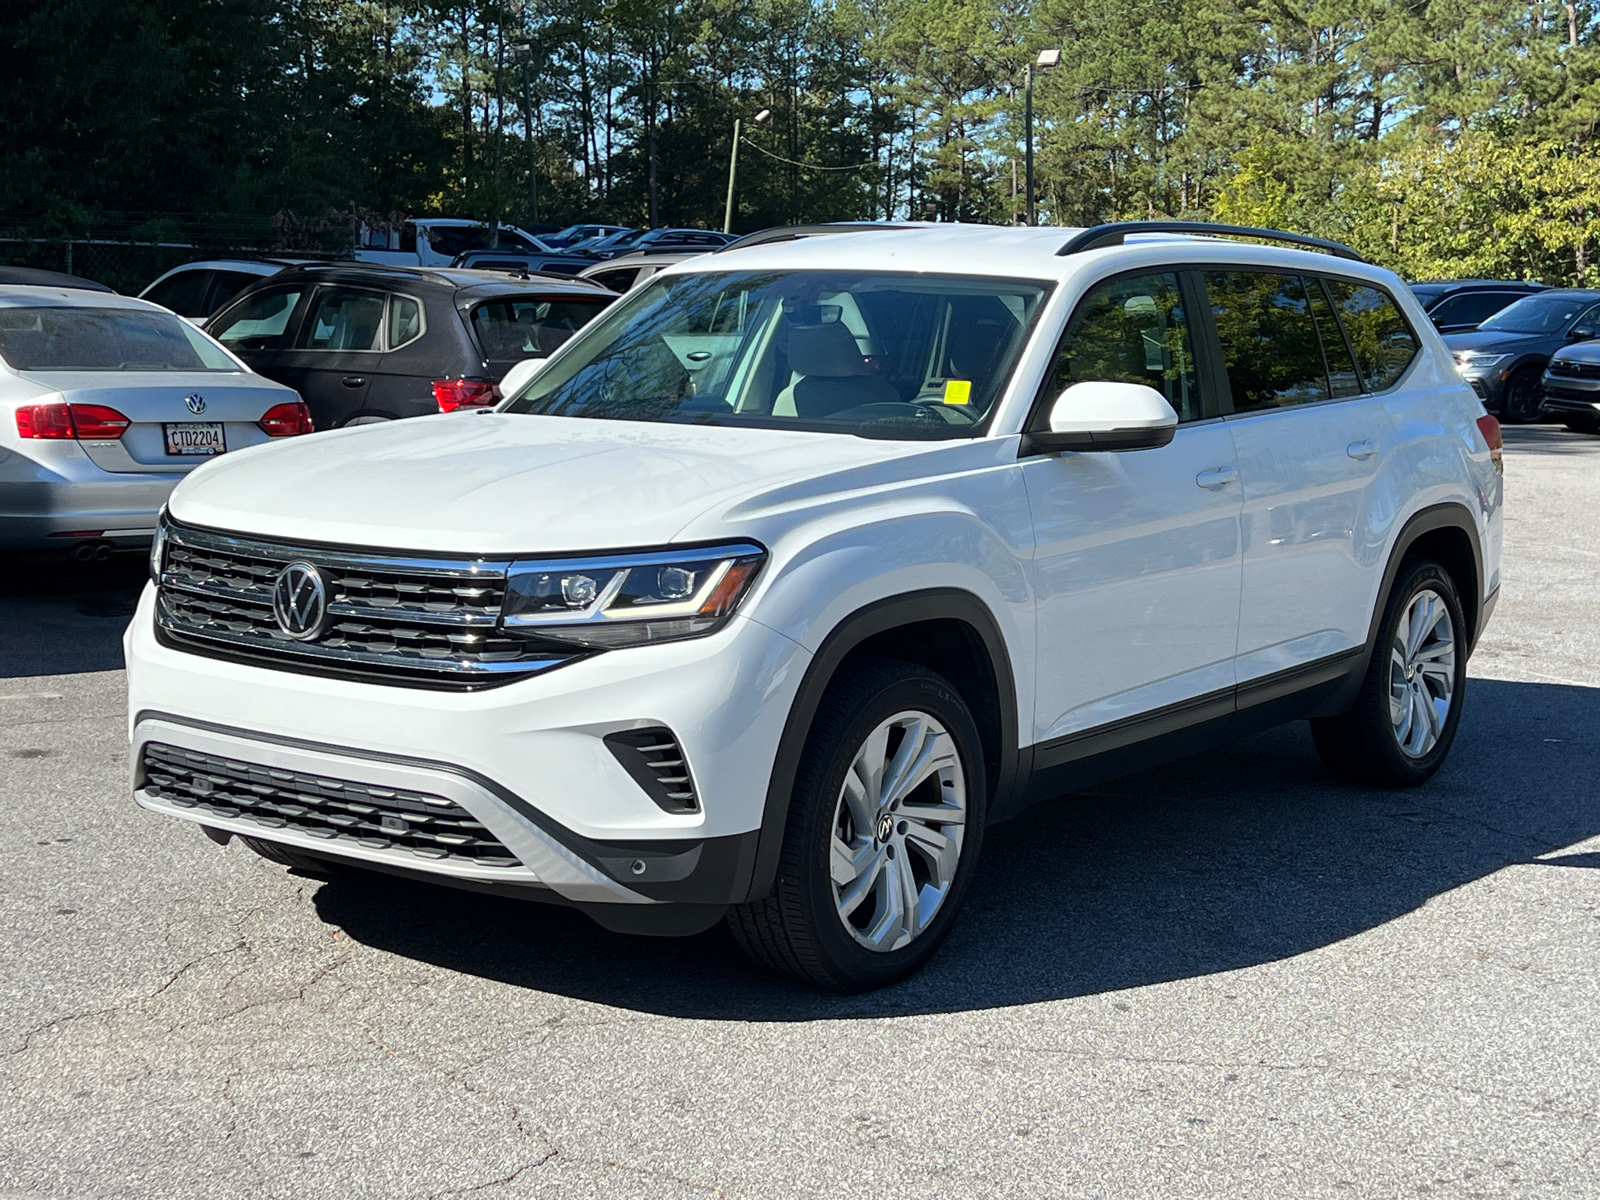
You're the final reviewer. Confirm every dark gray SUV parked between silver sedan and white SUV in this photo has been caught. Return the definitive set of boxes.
[206,264,616,429]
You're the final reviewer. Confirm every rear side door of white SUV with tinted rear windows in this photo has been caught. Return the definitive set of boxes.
[1198,267,1418,691]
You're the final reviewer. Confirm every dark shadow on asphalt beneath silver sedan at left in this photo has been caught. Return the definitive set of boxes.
[0,552,149,678]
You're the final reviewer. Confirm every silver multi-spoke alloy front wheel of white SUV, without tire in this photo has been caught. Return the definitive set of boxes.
[829,712,966,952]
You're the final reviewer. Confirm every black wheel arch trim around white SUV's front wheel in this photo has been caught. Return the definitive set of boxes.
[749,587,1022,899]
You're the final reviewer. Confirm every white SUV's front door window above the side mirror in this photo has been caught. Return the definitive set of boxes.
[1051,274,1200,421]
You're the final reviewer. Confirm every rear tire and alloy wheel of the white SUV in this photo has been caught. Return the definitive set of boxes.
[1310,560,1467,787]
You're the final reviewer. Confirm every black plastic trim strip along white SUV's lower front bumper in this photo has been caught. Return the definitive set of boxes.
[133,709,757,904]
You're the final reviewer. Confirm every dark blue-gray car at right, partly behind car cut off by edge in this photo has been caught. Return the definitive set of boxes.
[1445,288,1600,422]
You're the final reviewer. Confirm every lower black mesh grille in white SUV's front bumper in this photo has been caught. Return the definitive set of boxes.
[141,742,522,867]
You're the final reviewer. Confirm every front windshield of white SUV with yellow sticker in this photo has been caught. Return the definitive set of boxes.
[502,270,1050,438]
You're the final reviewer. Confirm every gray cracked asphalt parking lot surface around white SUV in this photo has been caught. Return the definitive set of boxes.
[0,427,1600,1200]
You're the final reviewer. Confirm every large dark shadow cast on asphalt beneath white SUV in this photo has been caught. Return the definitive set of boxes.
[315,680,1600,1021]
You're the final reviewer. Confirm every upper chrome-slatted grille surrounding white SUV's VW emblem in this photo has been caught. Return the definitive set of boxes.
[157,523,573,688]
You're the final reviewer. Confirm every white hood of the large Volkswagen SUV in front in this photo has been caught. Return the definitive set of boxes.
[168,413,960,555]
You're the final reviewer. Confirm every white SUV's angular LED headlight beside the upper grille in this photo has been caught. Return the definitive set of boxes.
[501,542,766,648]
